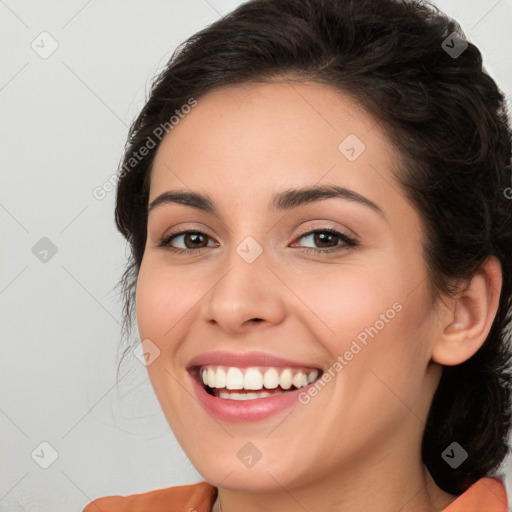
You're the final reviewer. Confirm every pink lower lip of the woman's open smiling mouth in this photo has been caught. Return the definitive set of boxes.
[189,374,314,422]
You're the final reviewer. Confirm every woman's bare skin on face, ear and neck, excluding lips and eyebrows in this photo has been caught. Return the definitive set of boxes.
[136,81,501,512]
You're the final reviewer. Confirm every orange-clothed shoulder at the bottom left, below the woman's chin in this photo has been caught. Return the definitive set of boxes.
[83,482,217,512]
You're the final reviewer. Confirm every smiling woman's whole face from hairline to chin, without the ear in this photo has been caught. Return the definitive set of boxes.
[136,82,439,491]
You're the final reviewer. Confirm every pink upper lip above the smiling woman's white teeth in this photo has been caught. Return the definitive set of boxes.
[188,350,321,370]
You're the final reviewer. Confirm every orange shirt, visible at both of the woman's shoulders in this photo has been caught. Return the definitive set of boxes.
[83,478,507,512]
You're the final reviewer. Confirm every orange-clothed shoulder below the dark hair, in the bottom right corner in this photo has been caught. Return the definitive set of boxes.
[443,478,508,512]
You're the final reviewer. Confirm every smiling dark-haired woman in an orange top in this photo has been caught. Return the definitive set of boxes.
[86,0,512,512]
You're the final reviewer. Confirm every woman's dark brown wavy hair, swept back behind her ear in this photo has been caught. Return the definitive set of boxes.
[115,0,512,494]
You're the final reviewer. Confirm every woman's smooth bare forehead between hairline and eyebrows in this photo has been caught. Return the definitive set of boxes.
[149,81,406,218]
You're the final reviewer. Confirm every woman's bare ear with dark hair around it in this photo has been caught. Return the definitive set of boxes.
[432,256,502,366]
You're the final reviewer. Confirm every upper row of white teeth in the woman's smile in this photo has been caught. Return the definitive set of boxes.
[201,366,318,390]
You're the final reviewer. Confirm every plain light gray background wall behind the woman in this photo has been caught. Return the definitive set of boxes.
[0,0,512,512]
